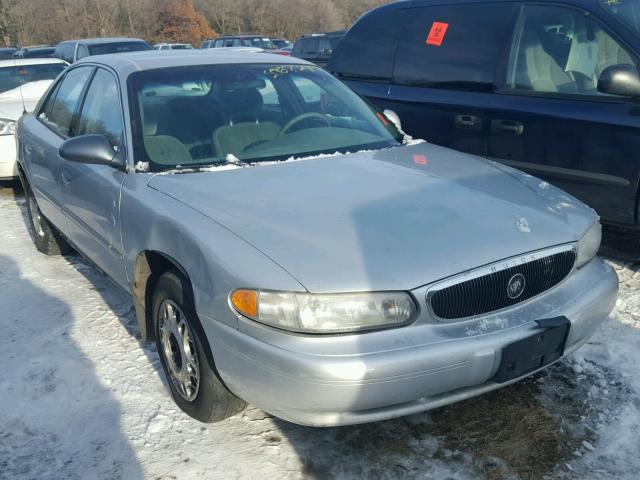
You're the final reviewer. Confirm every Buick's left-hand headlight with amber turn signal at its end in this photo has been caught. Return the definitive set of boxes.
[229,290,417,333]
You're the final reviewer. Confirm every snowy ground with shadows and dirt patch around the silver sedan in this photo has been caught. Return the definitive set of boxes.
[0,189,640,480]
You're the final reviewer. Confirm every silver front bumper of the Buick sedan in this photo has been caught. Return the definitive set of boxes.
[200,259,618,426]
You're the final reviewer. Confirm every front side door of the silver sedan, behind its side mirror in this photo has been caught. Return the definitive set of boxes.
[61,68,127,286]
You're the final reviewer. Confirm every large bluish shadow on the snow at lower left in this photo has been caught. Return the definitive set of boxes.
[0,254,143,480]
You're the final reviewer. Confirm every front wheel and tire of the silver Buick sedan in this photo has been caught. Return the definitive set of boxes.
[152,270,246,423]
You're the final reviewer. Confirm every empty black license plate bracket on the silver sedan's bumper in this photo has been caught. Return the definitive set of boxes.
[493,317,571,383]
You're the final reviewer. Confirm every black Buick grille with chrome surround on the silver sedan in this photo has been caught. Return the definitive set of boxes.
[428,248,576,320]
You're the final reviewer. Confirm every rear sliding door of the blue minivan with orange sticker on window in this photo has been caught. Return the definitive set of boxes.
[388,2,518,155]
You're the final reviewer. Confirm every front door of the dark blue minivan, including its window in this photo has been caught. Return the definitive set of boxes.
[487,4,640,224]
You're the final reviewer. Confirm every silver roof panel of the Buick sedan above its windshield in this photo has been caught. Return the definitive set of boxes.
[75,48,312,77]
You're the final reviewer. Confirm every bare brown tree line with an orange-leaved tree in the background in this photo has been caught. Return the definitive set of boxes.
[0,0,389,46]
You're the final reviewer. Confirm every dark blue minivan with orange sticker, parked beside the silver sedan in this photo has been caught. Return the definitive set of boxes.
[329,0,640,258]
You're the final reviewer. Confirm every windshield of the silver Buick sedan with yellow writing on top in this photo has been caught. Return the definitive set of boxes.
[129,64,401,171]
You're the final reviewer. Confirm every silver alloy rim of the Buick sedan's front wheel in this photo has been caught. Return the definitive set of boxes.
[159,299,200,402]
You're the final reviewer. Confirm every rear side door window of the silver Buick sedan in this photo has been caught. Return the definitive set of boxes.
[39,67,93,137]
